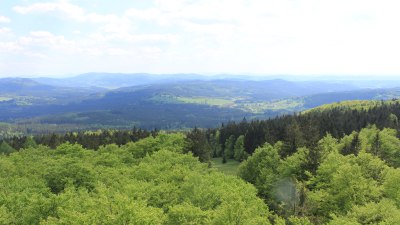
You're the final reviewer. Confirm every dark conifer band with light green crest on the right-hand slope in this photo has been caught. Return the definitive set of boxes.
[211,100,400,155]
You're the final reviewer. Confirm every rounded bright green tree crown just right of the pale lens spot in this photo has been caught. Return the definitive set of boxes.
[308,153,381,217]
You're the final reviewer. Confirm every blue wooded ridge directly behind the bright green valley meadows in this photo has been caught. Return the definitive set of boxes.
[112,79,356,100]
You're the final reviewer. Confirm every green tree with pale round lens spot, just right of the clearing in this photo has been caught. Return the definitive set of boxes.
[239,142,308,215]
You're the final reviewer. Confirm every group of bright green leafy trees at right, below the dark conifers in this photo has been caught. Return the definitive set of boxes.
[239,126,400,224]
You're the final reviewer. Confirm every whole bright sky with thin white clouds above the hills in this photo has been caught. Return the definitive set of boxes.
[0,0,400,77]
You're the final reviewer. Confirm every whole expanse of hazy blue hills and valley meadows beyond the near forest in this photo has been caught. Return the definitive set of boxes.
[0,73,400,132]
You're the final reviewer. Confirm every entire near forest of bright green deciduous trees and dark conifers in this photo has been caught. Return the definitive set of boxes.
[0,100,400,224]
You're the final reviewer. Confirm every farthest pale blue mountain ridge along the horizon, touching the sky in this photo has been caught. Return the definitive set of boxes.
[28,72,400,89]
